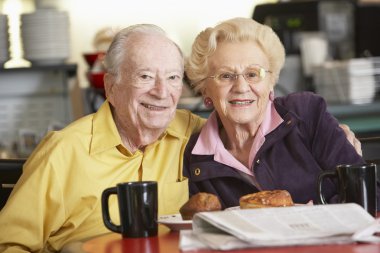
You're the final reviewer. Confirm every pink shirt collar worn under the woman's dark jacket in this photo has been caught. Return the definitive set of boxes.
[191,101,284,176]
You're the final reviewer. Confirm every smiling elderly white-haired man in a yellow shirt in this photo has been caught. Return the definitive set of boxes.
[0,25,203,252]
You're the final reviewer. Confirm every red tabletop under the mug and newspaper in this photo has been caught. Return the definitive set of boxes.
[82,225,380,253]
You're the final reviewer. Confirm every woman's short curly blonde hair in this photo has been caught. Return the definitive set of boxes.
[185,18,285,93]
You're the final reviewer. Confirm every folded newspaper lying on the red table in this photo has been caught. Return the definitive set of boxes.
[179,203,380,251]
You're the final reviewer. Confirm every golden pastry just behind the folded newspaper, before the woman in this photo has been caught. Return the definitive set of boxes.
[239,190,294,209]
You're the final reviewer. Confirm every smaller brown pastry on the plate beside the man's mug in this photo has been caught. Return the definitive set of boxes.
[179,192,222,220]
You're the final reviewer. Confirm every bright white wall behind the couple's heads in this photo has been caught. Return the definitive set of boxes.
[0,0,274,87]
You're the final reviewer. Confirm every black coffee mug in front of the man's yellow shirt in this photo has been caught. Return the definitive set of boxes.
[102,181,158,237]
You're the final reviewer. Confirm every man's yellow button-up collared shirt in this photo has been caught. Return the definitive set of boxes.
[0,102,205,252]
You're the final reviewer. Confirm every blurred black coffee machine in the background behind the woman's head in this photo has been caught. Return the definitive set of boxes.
[253,1,355,59]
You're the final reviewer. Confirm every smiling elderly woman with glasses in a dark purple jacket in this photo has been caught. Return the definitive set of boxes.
[184,18,378,208]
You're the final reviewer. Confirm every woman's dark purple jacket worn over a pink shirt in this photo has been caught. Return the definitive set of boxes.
[183,92,380,208]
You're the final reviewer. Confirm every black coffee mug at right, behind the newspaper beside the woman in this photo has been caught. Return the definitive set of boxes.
[317,164,377,217]
